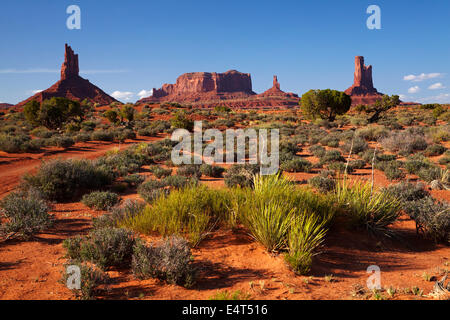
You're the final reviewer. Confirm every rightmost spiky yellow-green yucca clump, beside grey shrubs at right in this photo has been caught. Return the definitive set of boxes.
[335,180,401,235]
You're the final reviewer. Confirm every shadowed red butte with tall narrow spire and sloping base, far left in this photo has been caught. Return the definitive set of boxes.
[16,44,117,107]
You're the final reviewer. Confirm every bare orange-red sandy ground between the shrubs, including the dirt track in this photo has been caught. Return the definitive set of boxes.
[0,134,450,300]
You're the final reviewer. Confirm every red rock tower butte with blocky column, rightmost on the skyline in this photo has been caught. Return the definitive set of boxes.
[345,56,383,105]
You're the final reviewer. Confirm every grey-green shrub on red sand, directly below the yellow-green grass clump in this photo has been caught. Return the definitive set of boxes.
[131,237,197,287]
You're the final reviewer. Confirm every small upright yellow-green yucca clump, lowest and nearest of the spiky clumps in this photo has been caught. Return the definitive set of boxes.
[285,211,327,275]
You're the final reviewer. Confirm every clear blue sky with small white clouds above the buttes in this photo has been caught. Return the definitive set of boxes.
[0,0,450,103]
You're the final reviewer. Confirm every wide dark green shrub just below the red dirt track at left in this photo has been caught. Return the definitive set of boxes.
[24,159,112,200]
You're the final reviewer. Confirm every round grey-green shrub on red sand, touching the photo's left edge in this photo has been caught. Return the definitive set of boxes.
[0,190,54,239]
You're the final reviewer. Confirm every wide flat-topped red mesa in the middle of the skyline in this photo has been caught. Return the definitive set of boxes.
[138,70,255,103]
